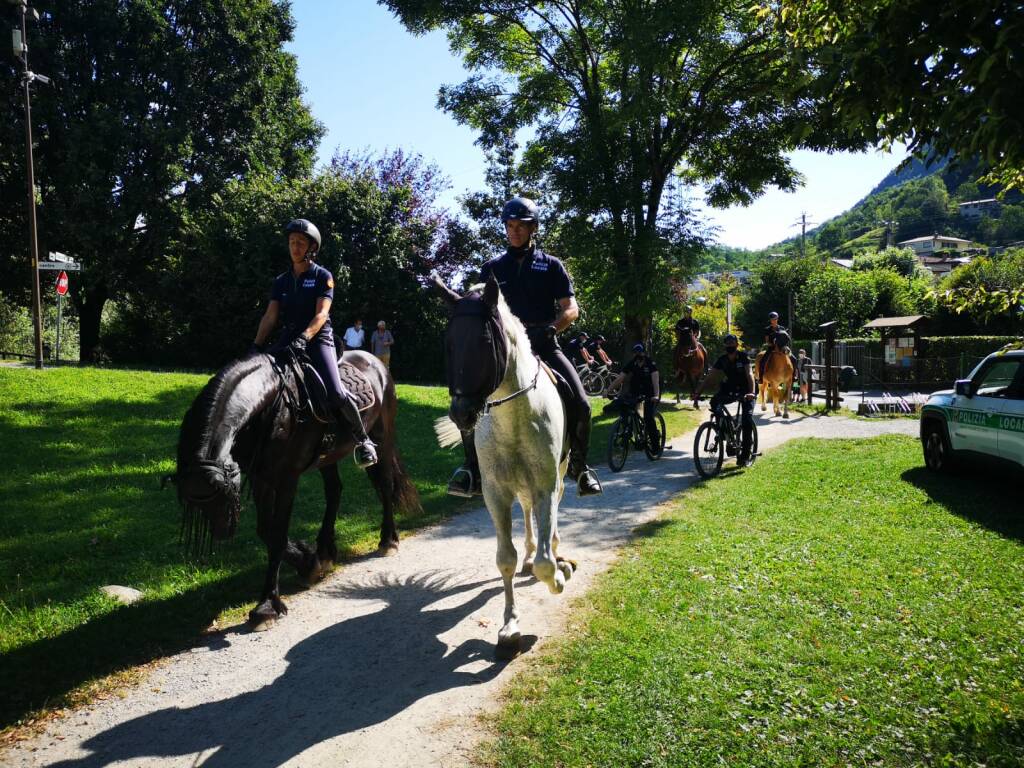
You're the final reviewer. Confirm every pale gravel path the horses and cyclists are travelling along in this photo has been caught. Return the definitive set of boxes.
[6,415,918,768]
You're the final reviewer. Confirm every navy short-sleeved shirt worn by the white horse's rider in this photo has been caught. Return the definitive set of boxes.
[480,249,575,326]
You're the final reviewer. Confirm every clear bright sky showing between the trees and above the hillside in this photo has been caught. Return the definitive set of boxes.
[290,0,903,248]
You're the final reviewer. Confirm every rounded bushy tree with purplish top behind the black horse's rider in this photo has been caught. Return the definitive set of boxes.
[103,152,478,381]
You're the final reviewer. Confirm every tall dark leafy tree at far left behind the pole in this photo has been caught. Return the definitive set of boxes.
[0,0,322,358]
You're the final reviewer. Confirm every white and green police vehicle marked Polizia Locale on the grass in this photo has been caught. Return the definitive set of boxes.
[921,347,1024,472]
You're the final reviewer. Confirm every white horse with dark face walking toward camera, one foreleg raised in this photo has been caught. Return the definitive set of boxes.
[434,278,575,648]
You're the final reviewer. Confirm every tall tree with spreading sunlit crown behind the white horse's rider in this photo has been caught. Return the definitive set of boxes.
[379,0,831,346]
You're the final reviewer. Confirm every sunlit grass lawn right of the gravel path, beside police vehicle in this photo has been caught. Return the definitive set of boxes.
[484,436,1024,767]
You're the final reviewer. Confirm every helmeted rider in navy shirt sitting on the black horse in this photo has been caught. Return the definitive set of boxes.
[252,219,377,468]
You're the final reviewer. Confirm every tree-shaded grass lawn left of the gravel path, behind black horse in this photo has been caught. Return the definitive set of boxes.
[0,368,695,729]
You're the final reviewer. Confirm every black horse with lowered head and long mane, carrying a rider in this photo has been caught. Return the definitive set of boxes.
[173,350,420,625]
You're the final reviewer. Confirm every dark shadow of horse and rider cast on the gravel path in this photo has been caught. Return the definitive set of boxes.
[56,573,504,768]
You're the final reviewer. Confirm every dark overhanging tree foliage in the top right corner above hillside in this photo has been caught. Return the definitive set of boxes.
[774,0,1024,189]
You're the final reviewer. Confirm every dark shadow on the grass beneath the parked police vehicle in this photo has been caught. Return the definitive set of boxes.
[901,462,1024,542]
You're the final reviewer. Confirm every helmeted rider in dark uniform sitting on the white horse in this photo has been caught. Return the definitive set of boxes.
[449,198,602,497]
